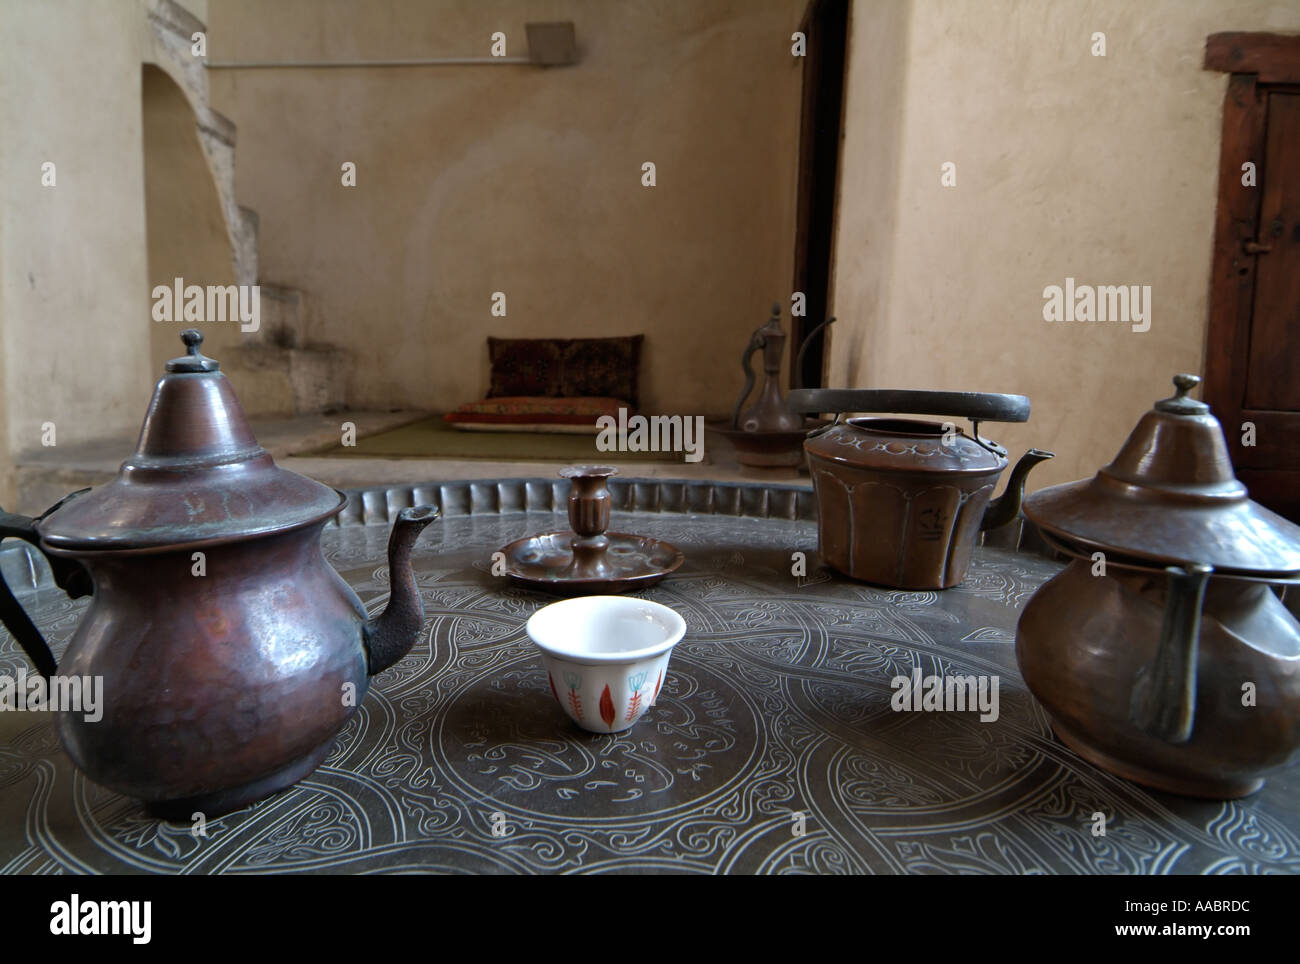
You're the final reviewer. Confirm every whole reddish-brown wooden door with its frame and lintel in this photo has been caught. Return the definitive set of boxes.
[1205,34,1300,521]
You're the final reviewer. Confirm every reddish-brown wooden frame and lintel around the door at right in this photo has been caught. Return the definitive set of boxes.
[1203,32,1300,514]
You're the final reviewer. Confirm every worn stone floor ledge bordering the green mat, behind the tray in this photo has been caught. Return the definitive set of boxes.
[14,411,809,516]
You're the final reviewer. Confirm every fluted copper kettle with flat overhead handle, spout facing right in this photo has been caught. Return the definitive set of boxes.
[790,388,1052,590]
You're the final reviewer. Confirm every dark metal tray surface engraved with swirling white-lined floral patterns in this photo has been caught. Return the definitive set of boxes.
[0,483,1300,874]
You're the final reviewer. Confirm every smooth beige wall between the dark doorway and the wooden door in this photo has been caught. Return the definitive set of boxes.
[831,0,1300,486]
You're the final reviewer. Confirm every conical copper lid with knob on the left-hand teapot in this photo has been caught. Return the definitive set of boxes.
[36,329,345,552]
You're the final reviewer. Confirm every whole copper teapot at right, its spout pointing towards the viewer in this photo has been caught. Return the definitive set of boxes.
[1015,375,1300,799]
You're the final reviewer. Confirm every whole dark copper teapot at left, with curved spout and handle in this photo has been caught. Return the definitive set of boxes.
[0,329,438,818]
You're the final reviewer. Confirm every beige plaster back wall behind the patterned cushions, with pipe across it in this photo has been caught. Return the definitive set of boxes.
[208,0,805,412]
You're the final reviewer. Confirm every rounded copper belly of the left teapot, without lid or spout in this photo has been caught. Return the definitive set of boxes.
[59,526,369,816]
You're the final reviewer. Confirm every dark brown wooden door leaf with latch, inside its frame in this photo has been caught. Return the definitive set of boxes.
[1245,94,1300,412]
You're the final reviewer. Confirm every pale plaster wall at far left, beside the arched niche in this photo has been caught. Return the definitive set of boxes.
[0,0,151,503]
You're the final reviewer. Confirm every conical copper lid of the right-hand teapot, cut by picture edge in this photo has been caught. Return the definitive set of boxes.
[1024,374,1300,577]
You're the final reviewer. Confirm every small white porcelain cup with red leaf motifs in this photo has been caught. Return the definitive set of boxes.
[527,596,686,733]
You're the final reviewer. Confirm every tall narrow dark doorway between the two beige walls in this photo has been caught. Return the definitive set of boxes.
[790,0,849,388]
